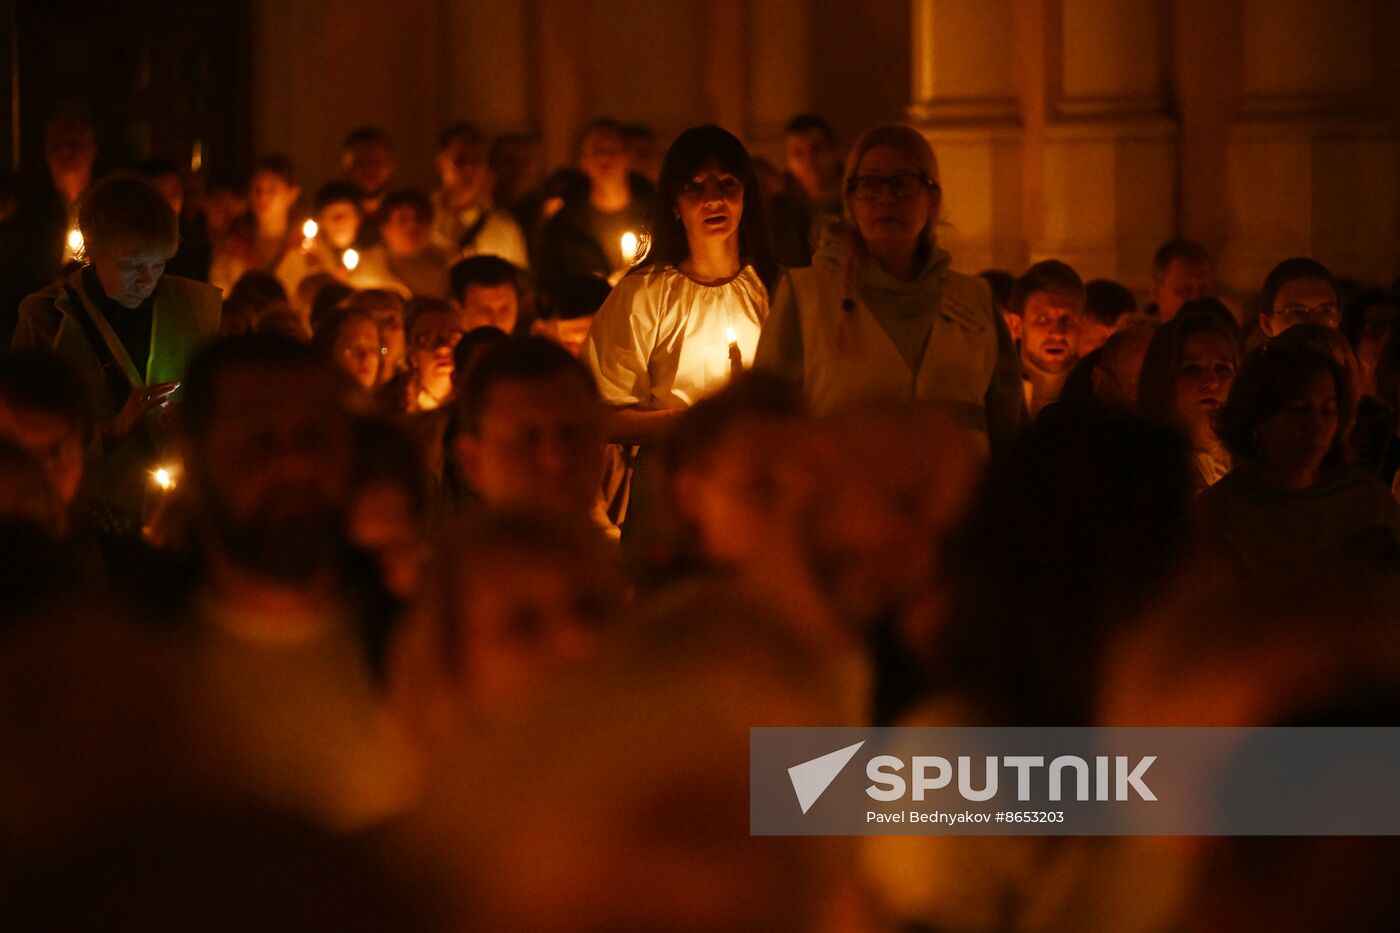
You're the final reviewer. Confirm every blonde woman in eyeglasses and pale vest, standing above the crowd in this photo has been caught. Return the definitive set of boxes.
[755,125,1025,451]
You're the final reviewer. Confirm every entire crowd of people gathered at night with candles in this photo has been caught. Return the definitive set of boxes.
[0,105,1400,933]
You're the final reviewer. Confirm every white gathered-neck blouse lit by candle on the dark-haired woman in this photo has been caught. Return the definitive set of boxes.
[581,266,769,410]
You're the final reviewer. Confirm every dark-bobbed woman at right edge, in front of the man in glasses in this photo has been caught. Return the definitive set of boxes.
[1198,339,1400,576]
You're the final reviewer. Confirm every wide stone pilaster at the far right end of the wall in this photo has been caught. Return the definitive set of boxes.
[1222,0,1400,290]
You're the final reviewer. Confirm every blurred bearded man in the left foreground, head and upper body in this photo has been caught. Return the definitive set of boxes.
[174,335,405,828]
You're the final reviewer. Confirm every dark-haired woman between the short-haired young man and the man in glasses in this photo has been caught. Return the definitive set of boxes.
[1138,298,1239,492]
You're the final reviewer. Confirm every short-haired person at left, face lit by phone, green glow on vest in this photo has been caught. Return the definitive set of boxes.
[13,175,221,516]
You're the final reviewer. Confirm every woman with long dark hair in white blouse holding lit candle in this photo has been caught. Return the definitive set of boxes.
[580,126,771,444]
